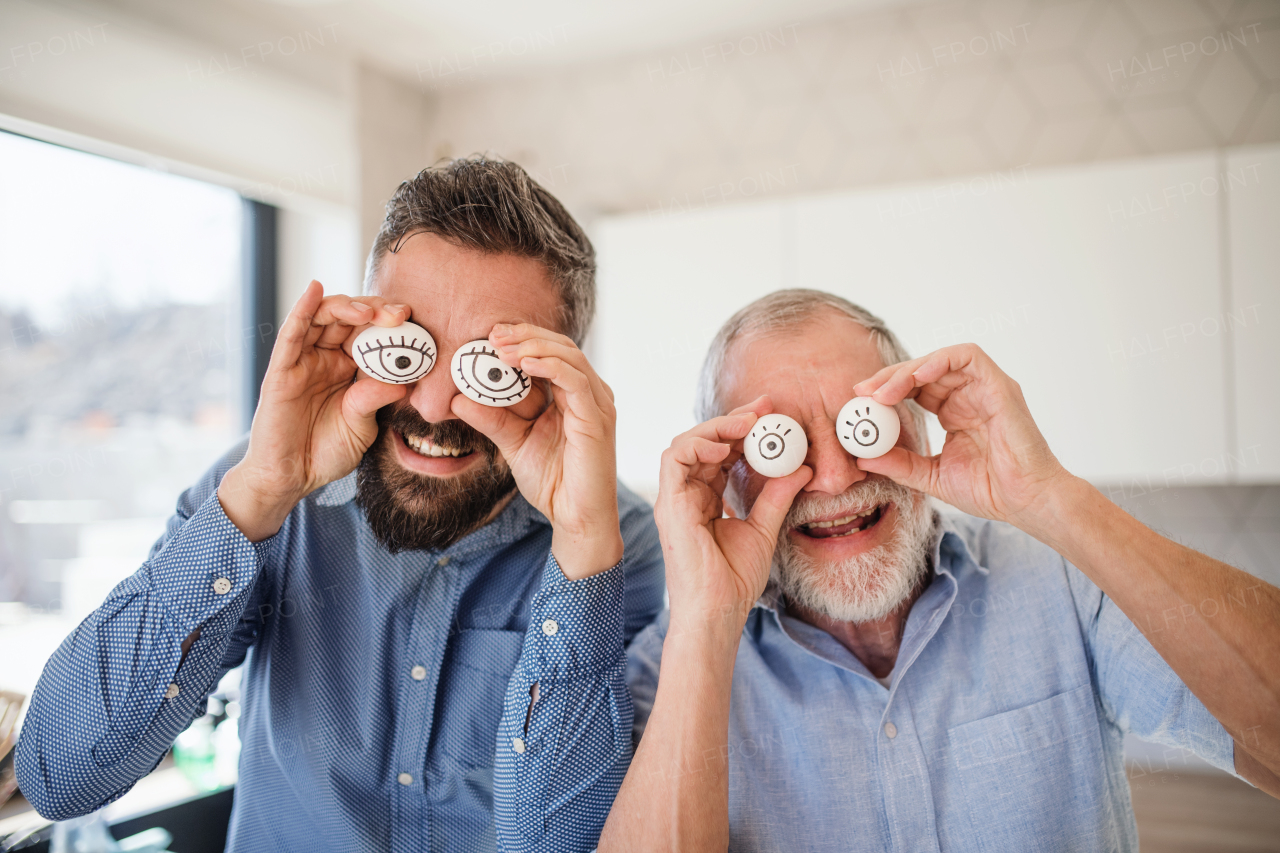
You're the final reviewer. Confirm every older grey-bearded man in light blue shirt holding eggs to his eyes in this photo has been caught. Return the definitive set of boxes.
[586,291,1280,853]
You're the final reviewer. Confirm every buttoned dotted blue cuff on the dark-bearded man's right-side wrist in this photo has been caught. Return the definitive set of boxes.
[521,555,626,684]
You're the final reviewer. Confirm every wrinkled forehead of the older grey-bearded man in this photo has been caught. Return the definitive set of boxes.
[722,310,884,410]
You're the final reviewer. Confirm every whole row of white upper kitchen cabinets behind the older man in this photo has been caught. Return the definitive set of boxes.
[593,146,1280,492]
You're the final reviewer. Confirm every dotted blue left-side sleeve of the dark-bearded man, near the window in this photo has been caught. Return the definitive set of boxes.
[14,438,269,820]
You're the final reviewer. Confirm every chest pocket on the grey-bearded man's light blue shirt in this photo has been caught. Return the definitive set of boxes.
[947,684,1112,853]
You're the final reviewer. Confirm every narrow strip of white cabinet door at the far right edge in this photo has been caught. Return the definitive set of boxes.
[1220,145,1280,483]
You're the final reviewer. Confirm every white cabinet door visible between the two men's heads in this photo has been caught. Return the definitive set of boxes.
[590,205,783,496]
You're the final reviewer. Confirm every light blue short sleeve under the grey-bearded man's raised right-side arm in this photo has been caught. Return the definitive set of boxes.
[1064,561,1235,775]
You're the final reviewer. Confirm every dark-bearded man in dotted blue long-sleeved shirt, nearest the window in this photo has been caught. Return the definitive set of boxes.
[17,159,663,853]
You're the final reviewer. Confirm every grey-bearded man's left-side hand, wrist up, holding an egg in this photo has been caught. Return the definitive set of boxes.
[654,397,813,628]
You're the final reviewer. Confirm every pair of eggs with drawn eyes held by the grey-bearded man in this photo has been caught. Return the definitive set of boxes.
[742,397,902,476]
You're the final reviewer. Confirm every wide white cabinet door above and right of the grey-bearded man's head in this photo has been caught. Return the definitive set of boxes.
[796,155,1226,488]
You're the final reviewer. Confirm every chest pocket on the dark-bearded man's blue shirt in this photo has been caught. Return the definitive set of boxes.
[434,628,525,770]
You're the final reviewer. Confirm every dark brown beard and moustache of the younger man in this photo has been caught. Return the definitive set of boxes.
[356,405,516,553]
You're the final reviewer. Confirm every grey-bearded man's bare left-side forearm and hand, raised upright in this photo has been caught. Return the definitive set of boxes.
[599,398,813,852]
